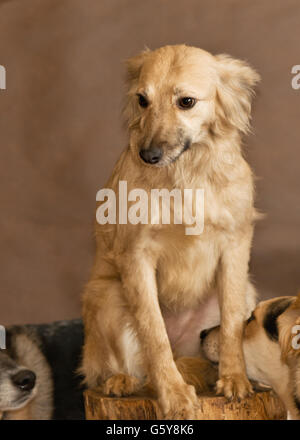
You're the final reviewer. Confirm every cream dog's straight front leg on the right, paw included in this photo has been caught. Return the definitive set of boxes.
[217,231,252,399]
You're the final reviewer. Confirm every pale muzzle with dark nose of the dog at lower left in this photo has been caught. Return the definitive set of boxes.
[0,350,36,418]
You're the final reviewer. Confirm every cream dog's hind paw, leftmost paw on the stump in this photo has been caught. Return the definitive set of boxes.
[102,374,140,397]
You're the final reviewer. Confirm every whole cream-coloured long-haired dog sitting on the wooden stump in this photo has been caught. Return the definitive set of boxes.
[81,45,259,418]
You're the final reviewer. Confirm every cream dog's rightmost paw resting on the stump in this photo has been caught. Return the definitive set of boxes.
[217,374,253,400]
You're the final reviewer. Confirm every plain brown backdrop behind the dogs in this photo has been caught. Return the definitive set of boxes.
[0,0,300,324]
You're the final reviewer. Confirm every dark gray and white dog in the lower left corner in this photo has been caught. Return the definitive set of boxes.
[0,319,84,420]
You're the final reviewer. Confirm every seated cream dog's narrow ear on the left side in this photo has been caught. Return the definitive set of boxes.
[123,48,151,126]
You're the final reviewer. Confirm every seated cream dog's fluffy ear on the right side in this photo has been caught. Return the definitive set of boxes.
[215,54,260,133]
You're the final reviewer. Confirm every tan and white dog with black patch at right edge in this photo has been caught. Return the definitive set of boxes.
[201,294,300,420]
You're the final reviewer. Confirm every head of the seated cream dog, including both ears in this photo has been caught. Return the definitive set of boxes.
[125,45,259,167]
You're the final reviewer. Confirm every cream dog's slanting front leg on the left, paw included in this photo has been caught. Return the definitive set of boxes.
[120,252,197,419]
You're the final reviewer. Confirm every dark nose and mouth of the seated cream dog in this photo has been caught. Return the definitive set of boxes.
[139,139,191,167]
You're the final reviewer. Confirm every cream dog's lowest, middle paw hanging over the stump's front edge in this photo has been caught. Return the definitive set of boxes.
[159,383,199,420]
